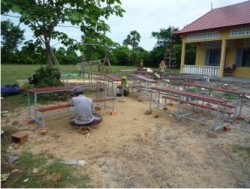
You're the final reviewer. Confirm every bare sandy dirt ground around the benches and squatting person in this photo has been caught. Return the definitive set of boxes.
[2,88,250,188]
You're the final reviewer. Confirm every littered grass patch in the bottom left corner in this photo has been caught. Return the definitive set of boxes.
[2,151,90,188]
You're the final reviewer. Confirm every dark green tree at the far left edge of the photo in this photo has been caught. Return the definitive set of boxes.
[1,20,24,62]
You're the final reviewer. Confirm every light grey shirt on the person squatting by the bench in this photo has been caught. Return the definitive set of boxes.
[70,95,95,124]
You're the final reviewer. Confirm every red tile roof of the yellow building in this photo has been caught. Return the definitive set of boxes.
[175,0,250,34]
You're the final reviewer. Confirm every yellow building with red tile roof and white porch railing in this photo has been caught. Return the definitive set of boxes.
[174,0,250,78]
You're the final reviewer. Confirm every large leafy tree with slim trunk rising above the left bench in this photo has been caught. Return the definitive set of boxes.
[1,0,125,66]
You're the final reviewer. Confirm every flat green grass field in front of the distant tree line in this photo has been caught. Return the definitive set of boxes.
[1,64,135,85]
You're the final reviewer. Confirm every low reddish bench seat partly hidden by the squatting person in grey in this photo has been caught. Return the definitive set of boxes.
[37,97,115,127]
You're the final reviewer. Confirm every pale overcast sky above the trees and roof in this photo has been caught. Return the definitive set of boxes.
[1,0,247,51]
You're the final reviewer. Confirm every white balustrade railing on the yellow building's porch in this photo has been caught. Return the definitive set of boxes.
[182,65,220,76]
